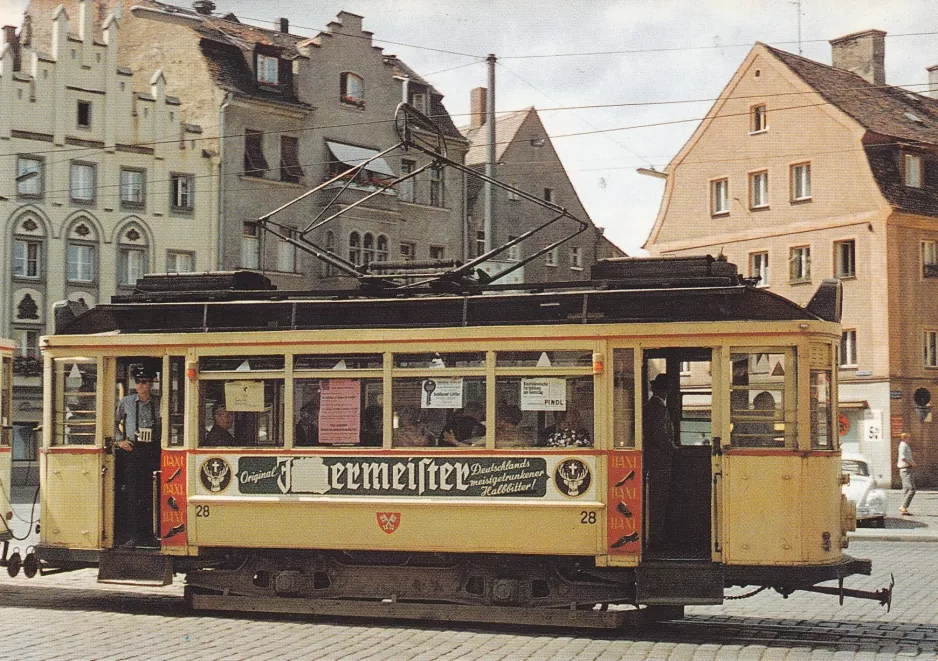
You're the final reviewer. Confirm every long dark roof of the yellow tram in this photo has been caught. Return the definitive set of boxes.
[56,257,839,335]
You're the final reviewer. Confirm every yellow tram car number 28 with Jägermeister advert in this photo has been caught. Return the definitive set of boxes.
[25,257,871,626]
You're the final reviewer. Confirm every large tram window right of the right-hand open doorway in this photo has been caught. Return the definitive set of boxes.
[730,350,797,448]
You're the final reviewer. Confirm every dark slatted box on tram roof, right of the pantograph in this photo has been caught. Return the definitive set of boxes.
[592,255,745,288]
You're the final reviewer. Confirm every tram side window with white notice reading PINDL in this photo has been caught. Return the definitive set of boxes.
[495,376,593,448]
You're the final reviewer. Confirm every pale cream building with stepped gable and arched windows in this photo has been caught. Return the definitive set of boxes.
[0,9,216,460]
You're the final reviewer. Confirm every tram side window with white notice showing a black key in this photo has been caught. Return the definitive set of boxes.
[392,376,485,447]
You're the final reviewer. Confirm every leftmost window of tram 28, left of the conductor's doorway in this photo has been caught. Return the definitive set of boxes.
[52,358,98,445]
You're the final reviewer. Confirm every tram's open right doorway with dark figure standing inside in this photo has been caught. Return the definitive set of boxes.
[642,347,720,561]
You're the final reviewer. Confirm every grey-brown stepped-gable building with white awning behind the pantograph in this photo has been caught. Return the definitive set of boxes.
[27,0,468,289]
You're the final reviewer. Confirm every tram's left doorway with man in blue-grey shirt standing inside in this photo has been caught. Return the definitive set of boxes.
[105,356,163,548]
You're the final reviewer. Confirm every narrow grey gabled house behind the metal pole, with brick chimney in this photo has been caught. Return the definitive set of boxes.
[462,88,624,282]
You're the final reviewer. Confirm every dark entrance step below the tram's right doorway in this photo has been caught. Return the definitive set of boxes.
[635,560,723,605]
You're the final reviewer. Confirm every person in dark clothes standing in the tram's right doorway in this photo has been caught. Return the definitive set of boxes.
[642,374,677,550]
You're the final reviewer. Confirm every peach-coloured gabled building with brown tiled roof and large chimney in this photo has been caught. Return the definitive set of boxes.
[646,30,938,486]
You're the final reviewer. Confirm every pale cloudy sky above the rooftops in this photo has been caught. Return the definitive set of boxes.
[0,0,938,255]
